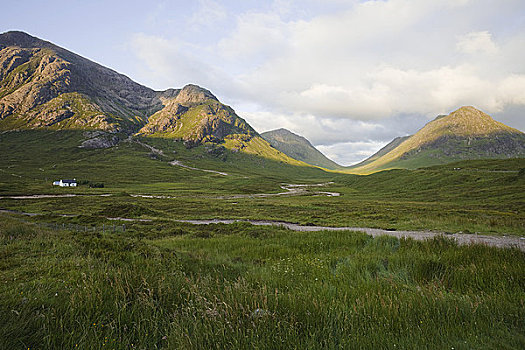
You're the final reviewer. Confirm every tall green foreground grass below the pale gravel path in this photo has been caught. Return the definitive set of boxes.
[0,216,525,349]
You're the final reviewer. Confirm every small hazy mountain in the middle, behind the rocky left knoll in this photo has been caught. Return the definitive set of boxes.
[261,129,343,170]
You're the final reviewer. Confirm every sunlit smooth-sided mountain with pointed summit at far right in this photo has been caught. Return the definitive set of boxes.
[349,106,525,173]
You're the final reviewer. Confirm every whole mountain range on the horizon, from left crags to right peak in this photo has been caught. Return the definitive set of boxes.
[0,31,525,174]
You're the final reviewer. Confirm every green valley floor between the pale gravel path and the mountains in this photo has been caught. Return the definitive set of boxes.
[0,131,525,235]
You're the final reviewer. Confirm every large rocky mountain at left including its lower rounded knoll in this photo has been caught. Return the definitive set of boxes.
[0,31,304,165]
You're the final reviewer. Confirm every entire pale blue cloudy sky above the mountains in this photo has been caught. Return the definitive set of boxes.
[0,0,525,165]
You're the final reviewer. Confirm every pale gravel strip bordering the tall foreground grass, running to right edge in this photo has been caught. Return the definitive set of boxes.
[175,219,525,251]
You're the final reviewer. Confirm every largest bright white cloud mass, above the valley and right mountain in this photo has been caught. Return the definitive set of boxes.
[225,0,524,120]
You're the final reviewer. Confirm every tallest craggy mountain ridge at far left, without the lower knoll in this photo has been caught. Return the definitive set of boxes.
[0,31,166,130]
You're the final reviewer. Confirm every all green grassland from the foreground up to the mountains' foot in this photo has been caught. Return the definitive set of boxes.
[0,131,525,349]
